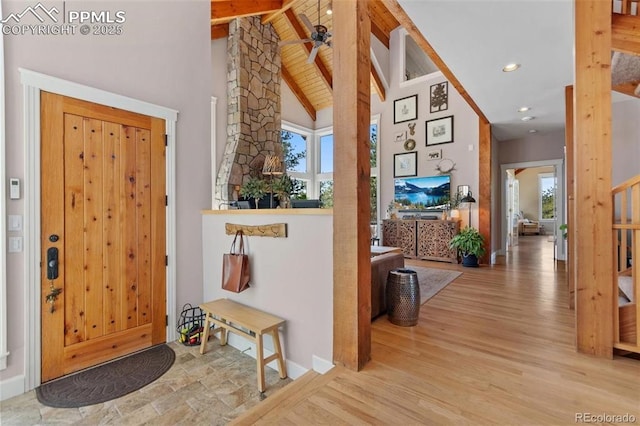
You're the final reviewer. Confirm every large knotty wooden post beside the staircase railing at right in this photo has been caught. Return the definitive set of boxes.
[571,0,613,358]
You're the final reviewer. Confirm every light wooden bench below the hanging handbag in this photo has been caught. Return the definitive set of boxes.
[200,299,287,393]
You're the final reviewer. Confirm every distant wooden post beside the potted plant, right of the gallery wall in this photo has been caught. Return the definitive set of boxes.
[478,117,492,264]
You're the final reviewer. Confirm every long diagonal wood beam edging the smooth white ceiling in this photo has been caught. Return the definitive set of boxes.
[381,0,489,122]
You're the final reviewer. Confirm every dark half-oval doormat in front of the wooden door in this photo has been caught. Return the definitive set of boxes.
[36,344,176,408]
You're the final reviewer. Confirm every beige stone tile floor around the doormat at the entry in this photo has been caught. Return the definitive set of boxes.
[0,340,291,426]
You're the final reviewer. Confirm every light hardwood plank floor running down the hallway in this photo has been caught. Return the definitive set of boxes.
[233,236,640,425]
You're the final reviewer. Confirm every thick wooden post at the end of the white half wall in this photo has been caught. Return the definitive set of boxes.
[333,0,371,370]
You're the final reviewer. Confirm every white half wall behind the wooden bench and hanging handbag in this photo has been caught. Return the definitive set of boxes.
[202,209,333,378]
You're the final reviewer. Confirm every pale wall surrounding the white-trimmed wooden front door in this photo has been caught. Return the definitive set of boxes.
[0,0,211,392]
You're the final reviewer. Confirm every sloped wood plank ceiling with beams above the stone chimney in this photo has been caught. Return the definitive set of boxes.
[211,0,400,120]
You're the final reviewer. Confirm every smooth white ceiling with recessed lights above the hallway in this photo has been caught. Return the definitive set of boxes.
[398,0,574,140]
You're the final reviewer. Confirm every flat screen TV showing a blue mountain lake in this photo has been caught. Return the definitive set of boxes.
[393,175,451,210]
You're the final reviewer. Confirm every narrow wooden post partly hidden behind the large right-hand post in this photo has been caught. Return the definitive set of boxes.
[560,86,576,309]
